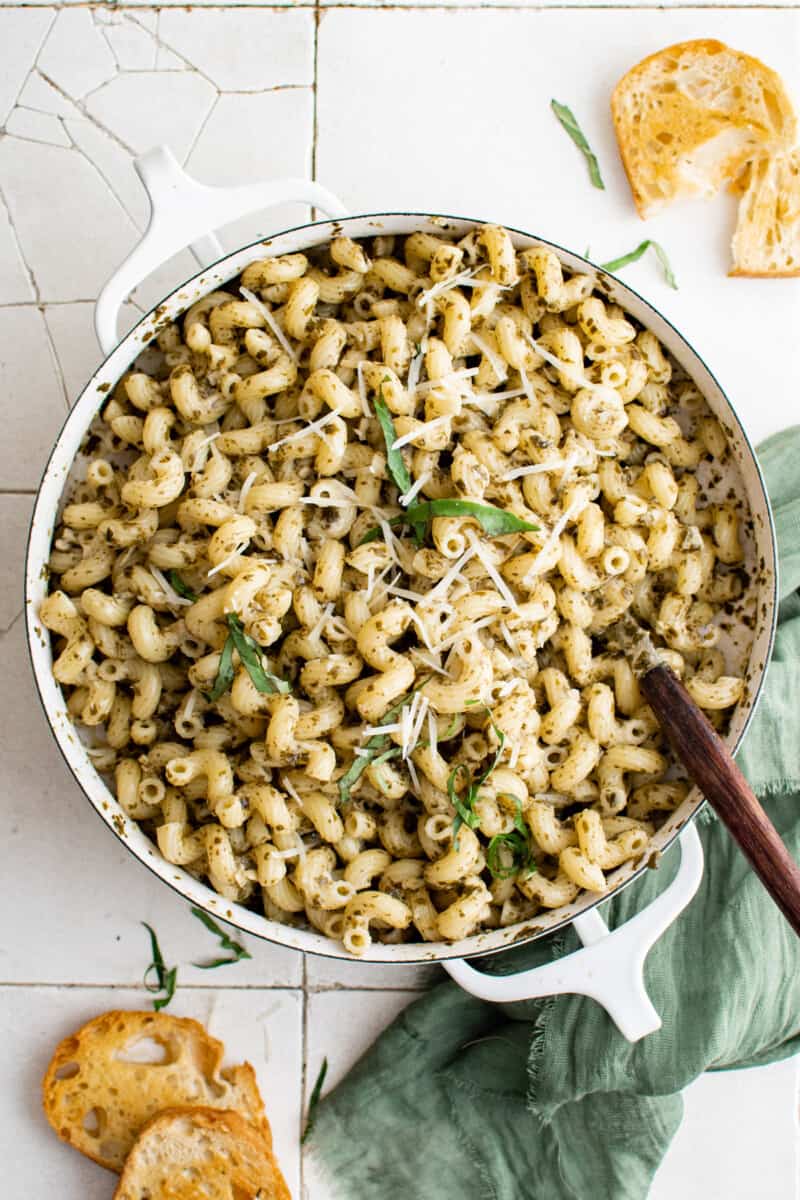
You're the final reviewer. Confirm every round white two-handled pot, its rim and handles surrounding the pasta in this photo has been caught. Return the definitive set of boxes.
[25,148,777,1040]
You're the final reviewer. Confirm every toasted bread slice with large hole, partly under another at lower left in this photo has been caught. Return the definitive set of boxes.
[42,1012,272,1172]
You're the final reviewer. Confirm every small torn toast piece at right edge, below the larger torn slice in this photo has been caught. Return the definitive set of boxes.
[729,150,800,276]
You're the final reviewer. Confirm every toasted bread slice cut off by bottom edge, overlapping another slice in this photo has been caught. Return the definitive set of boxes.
[114,1108,290,1200]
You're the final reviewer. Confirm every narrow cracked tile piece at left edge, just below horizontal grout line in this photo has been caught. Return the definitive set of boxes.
[0,307,65,491]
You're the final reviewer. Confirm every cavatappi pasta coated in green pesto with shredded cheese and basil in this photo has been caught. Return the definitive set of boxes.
[41,226,748,954]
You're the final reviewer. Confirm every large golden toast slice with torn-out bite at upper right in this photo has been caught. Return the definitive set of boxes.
[612,41,796,217]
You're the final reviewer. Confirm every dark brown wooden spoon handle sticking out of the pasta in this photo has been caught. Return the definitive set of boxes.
[639,666,800,935]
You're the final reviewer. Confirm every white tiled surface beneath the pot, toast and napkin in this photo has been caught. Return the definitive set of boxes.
[0,0,800,1200]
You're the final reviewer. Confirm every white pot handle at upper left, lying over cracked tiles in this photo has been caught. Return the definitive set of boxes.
[95,145,347,354]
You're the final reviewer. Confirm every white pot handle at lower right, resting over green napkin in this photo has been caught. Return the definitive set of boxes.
[441,823,703,1042]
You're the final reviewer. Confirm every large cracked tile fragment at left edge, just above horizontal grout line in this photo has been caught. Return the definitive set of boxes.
[0,137,136,301]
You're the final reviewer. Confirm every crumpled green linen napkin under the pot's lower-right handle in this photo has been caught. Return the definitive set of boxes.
[312,427,800,1200]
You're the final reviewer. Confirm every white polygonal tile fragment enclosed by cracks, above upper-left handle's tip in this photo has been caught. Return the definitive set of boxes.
[86,71,216,161]
